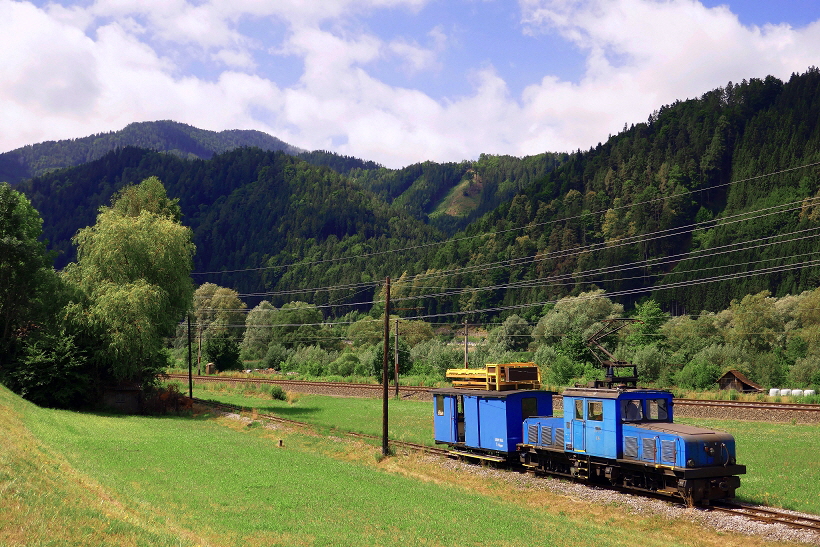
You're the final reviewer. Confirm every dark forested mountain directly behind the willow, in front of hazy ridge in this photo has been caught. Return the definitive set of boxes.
[19,148,436,297]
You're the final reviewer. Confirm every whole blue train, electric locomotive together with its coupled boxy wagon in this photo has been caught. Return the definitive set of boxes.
[432,386,746,505]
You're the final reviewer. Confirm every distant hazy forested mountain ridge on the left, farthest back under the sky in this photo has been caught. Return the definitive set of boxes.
[0,120,304,184]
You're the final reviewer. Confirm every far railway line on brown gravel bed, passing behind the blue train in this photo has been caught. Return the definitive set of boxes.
[165,374,820,412]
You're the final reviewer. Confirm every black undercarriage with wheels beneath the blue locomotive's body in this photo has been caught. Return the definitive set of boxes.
[519,445,740,506]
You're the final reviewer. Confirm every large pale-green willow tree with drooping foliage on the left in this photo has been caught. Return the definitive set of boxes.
[64,177,194,384]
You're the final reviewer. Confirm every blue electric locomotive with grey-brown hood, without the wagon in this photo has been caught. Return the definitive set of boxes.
[519,388,746,504]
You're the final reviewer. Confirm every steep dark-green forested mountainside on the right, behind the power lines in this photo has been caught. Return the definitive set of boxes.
[396,68,820,314]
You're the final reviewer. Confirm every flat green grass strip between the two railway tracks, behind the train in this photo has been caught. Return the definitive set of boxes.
[195,391,820,514]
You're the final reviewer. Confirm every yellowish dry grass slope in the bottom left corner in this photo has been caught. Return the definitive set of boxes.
[0,385,193,546]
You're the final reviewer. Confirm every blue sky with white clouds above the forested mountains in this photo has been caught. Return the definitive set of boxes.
[0,0,820,167]
